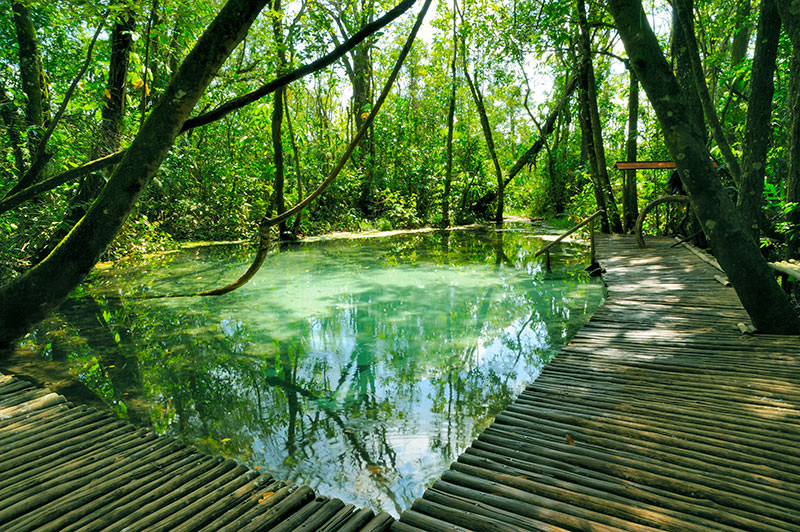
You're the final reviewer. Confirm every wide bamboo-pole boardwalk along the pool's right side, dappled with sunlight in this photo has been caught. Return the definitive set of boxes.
[392,237,800,532]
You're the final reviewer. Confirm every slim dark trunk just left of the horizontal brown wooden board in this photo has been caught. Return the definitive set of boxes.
[577,0,622,233]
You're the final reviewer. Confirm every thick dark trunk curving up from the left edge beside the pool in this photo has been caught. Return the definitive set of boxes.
[0,0,267,345]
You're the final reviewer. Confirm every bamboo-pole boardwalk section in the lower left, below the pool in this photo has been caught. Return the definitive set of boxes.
[0,375,392,532]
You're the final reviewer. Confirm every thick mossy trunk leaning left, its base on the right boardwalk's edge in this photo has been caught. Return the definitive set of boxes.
[607,0,800,334]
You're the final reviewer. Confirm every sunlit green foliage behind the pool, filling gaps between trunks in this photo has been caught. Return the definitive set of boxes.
[0,0,794,266]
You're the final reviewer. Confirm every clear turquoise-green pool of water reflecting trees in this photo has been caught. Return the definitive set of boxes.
[25,224,603,515]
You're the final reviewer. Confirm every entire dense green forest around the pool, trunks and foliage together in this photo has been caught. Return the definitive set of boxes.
[0,0,800,344]
